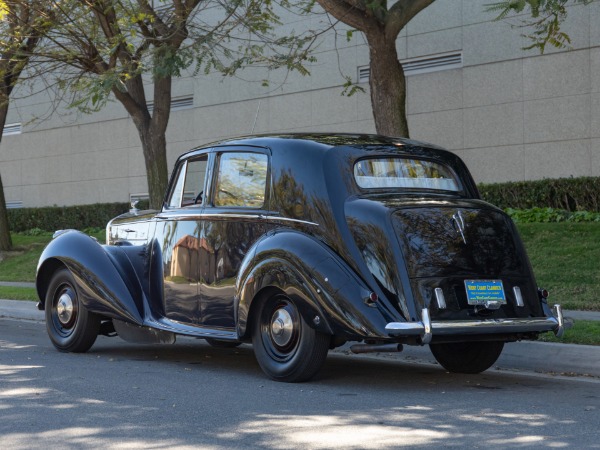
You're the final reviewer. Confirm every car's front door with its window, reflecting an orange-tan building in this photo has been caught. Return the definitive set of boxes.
[155,153,209,325]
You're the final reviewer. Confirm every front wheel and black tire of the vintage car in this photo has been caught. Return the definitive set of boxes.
[45,268,100,353]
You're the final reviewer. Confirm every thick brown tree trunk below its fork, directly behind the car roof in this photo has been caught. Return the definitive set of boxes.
[366,29,409,137]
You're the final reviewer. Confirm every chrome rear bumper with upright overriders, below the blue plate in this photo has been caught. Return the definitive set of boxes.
[385,305,573,345]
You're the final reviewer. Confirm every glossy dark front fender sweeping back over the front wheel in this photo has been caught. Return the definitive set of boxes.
[36,230,144,325]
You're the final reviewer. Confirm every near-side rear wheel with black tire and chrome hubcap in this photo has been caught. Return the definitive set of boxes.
[252,295,331,383]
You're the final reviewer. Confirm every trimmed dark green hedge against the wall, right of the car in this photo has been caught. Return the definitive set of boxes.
[478,177,600,212]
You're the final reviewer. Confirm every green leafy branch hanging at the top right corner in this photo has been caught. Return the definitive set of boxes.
[486,0,593,53]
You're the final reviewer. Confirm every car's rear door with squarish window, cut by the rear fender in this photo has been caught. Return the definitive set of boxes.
[200,148,270,329]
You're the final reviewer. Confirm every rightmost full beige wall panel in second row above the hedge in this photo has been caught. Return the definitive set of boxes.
[524,95,591,143]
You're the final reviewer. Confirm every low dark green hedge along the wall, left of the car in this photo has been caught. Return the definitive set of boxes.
[8,203,129,232]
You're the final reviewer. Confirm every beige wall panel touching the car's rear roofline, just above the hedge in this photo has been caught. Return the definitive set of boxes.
[456,145,525,183]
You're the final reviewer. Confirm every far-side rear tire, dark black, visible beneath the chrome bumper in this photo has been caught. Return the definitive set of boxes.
[429,341,504,373]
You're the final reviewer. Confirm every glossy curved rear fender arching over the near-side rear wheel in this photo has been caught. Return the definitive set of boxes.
[236,231,387,339]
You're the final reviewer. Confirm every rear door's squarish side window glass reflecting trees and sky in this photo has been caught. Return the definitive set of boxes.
[214,152,268,208]
